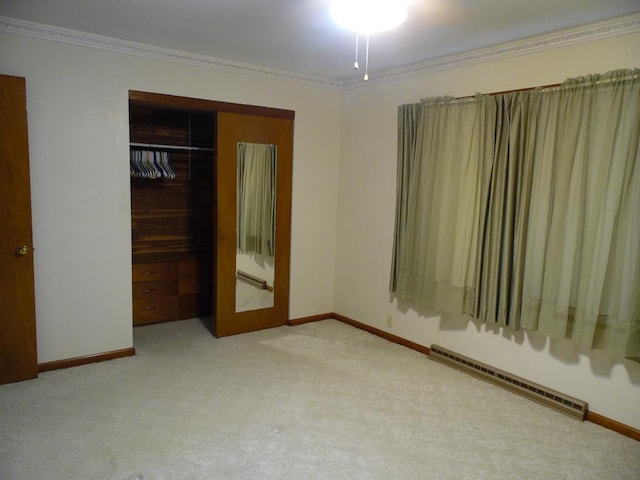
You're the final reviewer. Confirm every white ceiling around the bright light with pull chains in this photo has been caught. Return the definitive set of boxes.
[0,0,640,81]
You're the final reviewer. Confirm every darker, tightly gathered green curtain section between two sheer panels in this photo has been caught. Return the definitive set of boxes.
[474,91,539,330]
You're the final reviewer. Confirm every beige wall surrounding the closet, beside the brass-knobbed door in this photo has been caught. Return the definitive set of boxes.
[0,33,341,363]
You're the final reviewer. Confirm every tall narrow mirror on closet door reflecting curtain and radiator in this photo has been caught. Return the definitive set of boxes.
[236,142,277,312]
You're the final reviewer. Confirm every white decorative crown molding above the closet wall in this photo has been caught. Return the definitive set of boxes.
[0,16,342,89]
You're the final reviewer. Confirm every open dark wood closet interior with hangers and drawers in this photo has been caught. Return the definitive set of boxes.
[129,100,216,326]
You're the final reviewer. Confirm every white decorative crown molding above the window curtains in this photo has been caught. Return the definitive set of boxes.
[342,13,640,88]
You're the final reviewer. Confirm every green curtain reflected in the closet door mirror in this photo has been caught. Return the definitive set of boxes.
[237,143,276,257]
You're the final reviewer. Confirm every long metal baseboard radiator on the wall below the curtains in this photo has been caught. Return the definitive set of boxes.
[429,345,588,420]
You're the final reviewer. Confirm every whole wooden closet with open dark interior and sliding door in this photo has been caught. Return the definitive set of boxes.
[129,91,294,336]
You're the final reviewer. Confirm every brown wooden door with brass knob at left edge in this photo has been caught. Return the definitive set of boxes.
[0,75,38,384]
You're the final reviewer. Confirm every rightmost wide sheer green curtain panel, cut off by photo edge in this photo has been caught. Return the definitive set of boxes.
[522,71,640,357]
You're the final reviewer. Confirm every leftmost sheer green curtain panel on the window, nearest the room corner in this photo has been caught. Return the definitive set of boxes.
[391,96,495,313]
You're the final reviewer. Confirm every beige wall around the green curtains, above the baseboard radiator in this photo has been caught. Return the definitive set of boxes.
[335,34,640,428]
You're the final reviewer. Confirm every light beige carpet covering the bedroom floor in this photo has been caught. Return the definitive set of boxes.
[0,320,640,480]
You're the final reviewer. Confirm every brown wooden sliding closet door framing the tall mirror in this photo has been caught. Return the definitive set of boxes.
[213,111,293,337]
